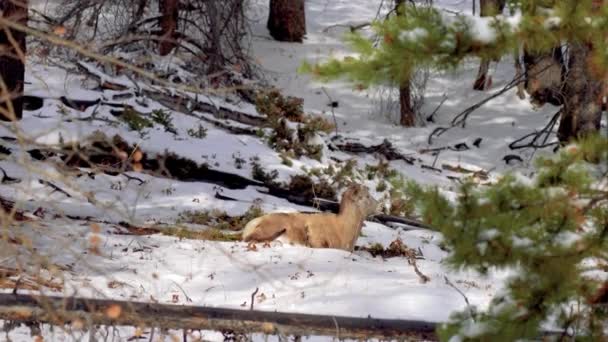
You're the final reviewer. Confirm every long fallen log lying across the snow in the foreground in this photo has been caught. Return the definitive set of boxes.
[0,294,437,340]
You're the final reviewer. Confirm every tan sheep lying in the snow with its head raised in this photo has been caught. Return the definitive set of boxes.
[243,185,378,251]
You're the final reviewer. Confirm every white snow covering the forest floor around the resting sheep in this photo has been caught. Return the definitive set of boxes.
[0,0,604,340]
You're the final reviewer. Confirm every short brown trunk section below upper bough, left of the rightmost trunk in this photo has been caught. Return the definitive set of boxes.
[524,46,566,106]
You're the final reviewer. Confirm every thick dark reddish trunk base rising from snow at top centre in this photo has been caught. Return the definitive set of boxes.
[267,0,306,43]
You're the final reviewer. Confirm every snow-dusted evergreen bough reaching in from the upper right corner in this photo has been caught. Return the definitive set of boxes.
[300,0,608,89]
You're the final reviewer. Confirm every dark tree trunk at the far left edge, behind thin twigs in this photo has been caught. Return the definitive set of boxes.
[0,0,28,121]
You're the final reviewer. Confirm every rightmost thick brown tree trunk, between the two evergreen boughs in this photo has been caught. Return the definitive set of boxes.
[557,43,603,143]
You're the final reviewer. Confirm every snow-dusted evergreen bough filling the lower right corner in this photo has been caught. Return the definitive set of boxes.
[409,136,608,341]
